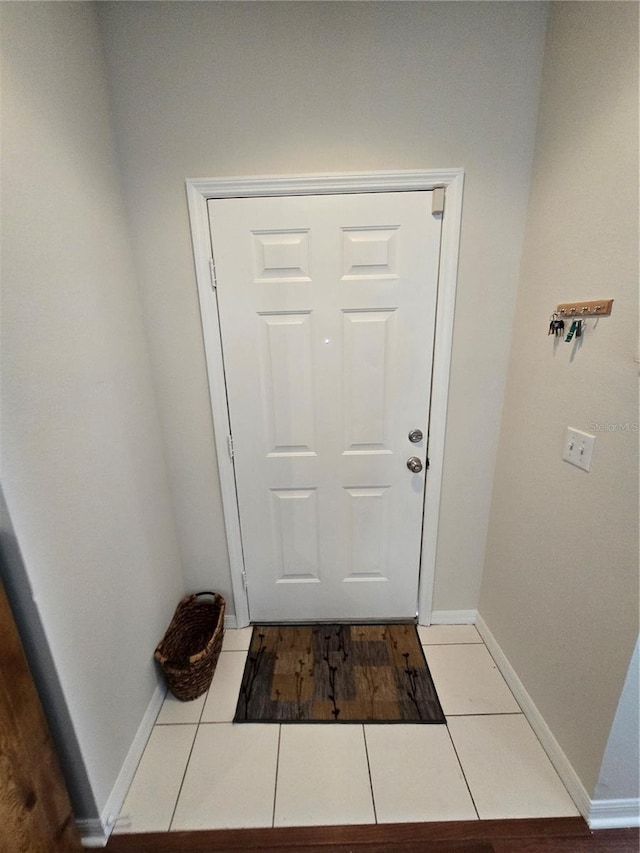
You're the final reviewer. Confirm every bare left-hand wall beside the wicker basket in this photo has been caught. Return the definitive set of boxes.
[0,3,183,818]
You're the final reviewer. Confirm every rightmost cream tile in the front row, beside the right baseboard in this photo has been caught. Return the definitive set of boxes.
[449,714,578,820]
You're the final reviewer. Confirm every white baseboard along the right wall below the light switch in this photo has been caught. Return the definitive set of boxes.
[476,614,591,820]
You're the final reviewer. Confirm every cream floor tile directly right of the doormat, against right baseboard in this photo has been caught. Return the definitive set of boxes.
[423,644,520,718]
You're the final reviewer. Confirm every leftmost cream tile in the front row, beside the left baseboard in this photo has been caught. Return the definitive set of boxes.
[115,725,197,832]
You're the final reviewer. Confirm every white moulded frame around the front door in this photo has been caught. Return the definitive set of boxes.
[186,169,464,628]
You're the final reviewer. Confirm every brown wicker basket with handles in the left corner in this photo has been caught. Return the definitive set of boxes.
[154,592,226,702]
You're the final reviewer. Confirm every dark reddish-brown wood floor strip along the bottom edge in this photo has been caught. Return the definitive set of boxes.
[106,820,640,853]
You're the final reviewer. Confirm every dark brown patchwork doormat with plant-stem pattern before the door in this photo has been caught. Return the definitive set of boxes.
[234,624,446,723]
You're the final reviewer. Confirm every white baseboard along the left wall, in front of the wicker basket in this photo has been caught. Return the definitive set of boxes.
[77,684,167,847]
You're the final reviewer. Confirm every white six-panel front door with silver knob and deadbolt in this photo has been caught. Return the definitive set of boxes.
[208,191,440,622]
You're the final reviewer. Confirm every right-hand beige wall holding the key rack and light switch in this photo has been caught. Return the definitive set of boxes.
[480,2,639,797]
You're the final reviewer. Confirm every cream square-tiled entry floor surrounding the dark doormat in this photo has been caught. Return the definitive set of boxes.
[116,625,578,832]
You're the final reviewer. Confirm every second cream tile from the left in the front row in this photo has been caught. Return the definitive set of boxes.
[171,723,280,830]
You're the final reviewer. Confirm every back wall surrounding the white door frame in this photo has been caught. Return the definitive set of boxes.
[100,2,546,610]
